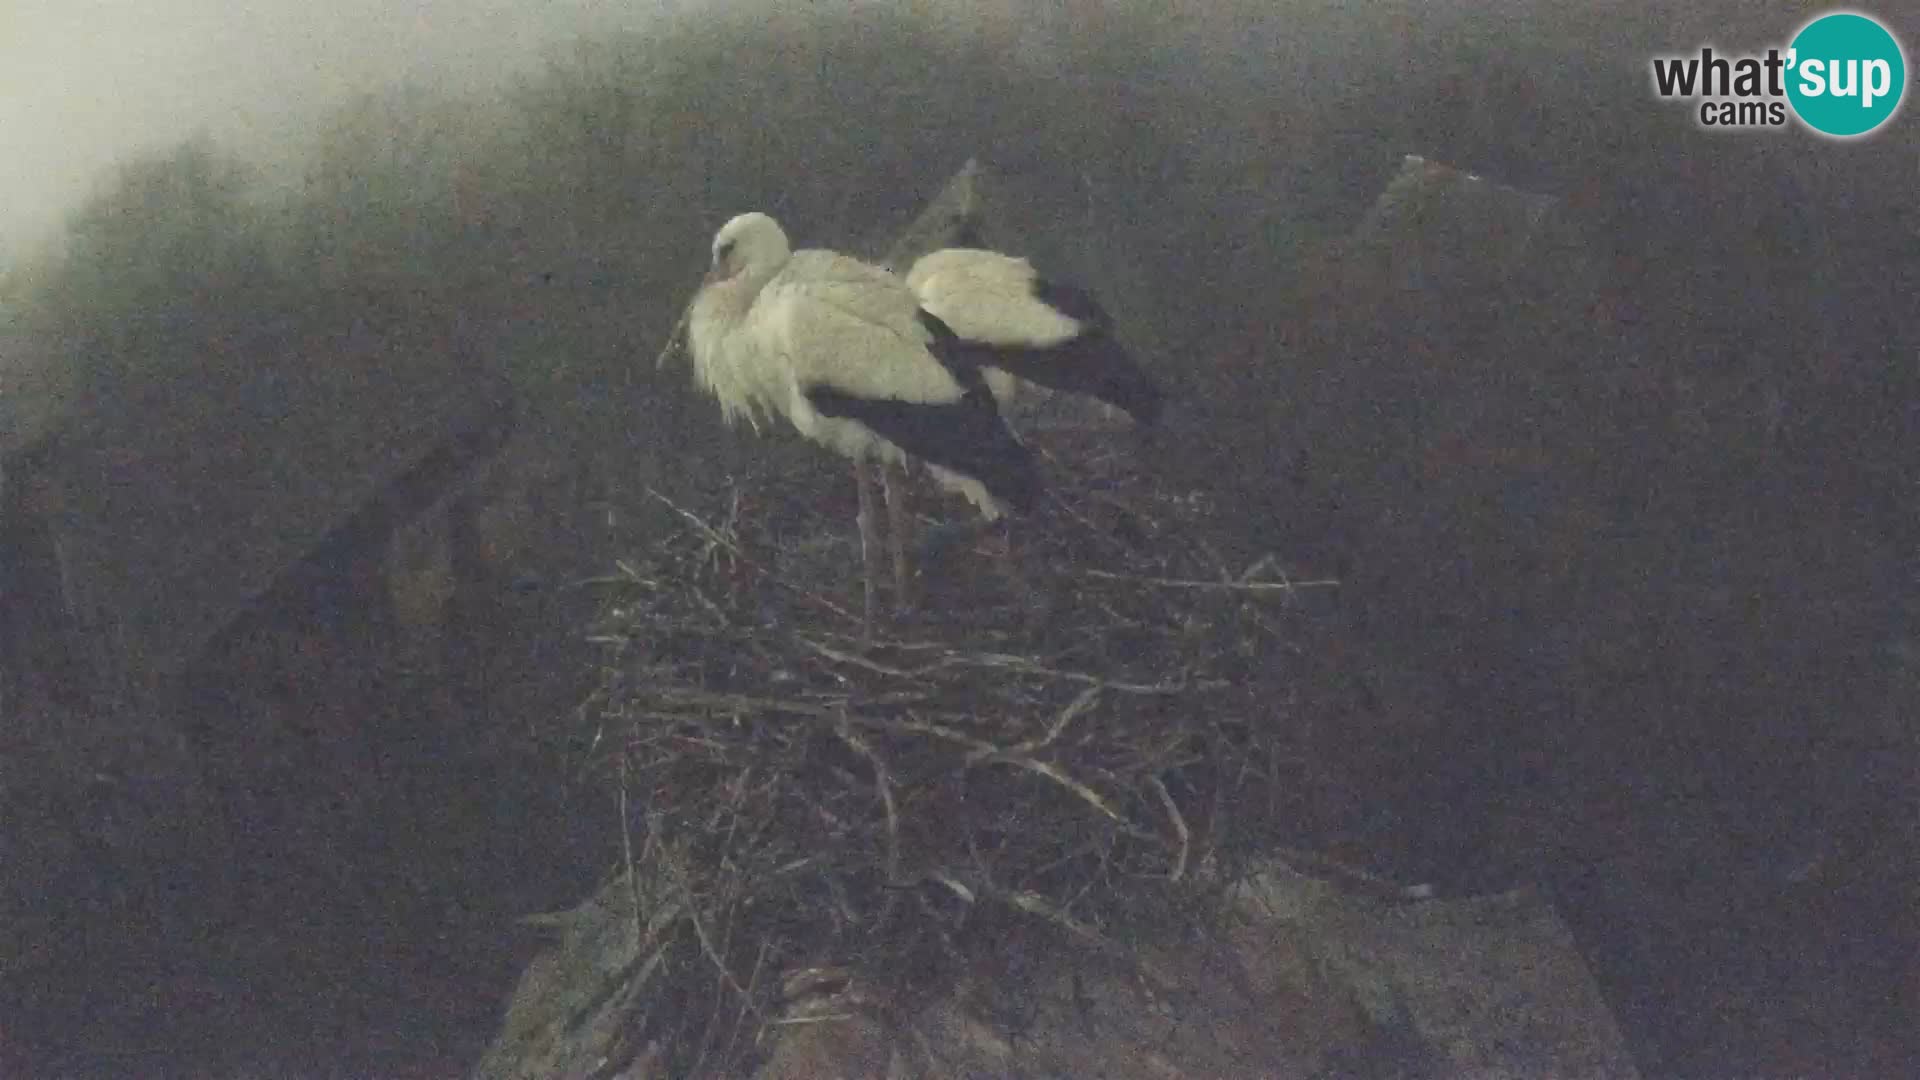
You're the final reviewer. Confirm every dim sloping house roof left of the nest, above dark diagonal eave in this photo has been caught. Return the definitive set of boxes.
[31,315,511,684]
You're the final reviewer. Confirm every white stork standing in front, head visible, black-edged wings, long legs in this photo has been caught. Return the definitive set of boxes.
[687,213,1041,632]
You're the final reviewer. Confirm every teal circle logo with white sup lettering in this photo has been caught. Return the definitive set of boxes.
[1788,12,1907,138]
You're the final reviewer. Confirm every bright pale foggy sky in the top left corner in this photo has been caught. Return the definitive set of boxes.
[0,0,672,252]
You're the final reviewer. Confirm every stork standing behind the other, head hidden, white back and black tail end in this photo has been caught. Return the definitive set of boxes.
[906,248,1164,425]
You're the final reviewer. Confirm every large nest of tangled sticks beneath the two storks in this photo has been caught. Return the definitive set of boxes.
[572,418,1329,1076]
